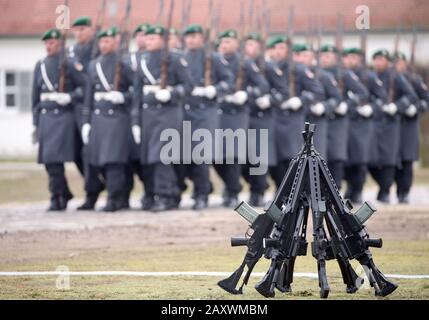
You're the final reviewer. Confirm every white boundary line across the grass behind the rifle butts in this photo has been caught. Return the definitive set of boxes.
[0,271,429,279]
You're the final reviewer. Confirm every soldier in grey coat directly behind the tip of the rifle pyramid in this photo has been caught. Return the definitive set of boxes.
[294,44,341,159]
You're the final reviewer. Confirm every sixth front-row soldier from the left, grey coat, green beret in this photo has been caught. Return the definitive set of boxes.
[243,32,288,207]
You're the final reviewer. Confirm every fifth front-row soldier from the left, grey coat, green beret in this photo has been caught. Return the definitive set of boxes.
[215,30,269,207]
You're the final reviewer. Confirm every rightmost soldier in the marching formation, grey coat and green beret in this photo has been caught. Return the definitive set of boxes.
[395,53,429,203]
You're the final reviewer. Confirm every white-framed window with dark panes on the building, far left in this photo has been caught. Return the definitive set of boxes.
[0,70,32,111]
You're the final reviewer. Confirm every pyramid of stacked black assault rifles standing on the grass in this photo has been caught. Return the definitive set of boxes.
[218,123,397,298]
